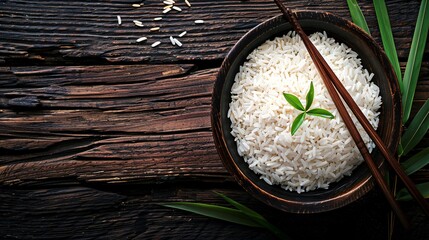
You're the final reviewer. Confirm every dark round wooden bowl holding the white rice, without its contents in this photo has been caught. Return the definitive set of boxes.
[211,11,401,213]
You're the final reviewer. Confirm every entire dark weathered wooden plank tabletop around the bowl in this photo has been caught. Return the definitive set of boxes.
[0,0,429,240]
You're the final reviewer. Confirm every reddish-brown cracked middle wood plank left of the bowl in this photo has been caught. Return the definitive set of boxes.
[0,63,429,185]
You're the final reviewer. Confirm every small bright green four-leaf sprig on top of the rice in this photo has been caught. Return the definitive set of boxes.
[283,82,335,136]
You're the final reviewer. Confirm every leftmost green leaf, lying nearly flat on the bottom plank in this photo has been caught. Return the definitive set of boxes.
[160,202,263,228]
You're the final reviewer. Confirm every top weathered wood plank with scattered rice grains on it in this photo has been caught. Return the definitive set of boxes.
[0,0,419,65]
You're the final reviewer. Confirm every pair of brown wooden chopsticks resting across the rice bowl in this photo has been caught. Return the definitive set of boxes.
[274,0,429,229]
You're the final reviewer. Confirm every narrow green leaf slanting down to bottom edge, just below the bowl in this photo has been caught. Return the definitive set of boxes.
[215,192,291,240]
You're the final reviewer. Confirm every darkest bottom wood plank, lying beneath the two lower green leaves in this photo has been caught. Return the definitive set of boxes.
[0,185,416,240]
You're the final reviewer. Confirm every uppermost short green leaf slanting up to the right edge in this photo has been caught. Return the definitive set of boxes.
[400,99,429,155]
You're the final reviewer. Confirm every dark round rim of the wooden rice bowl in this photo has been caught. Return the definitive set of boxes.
[211,10,402,213]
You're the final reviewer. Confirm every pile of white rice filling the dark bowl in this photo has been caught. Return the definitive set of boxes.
[228,32,381,193]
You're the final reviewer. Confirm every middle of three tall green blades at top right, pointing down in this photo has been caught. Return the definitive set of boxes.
[373,0,404,93]
